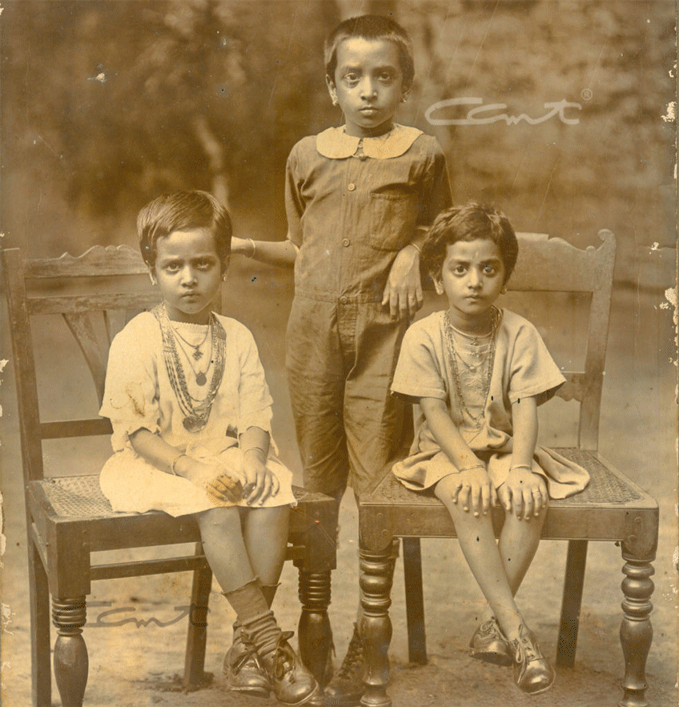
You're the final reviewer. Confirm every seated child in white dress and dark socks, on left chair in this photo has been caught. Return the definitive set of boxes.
[100,191,317,705]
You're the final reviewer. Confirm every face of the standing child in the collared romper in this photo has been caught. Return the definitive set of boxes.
[326,37,405,137]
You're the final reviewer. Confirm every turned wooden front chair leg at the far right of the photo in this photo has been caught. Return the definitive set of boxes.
[619,550,655,707]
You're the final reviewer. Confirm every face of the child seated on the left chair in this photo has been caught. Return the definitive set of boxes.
[151,228,222,324]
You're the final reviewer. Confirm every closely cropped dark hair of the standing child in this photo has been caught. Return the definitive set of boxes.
[324,15,415,90]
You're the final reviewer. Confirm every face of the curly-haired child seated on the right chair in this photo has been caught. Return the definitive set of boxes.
[434,238,505,331]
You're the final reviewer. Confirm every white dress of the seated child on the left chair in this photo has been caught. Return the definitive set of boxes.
[99,312,295,516]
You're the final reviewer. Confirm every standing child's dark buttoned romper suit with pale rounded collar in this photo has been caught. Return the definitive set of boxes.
[286,125,451,497]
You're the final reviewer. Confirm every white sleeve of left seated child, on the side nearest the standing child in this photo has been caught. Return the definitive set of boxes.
[232,324,273,434]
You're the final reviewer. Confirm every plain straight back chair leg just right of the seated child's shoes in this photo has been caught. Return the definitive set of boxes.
[556,540,587,668]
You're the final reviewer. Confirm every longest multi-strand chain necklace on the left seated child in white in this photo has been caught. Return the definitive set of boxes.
[153,304,226,432]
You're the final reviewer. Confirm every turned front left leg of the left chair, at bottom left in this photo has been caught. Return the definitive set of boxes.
[52,596,89,707]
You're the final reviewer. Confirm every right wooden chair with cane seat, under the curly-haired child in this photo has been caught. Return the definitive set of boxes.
[359,230,658,707]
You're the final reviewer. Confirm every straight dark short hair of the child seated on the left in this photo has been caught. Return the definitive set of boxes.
[137,190,232,270]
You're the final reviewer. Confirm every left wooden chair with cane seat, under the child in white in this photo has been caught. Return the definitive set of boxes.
[2,246,335,707]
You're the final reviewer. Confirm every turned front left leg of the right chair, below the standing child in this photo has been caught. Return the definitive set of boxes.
[359,543,395,707]
